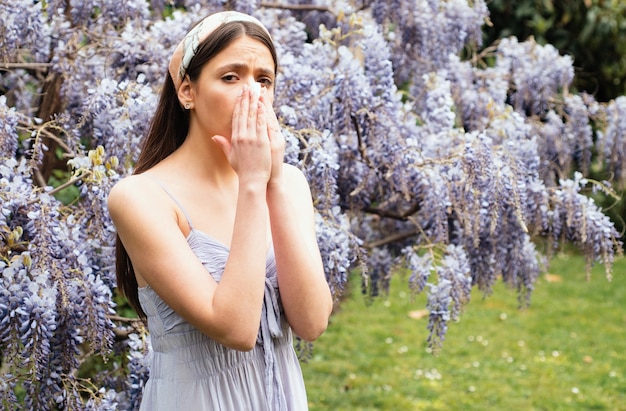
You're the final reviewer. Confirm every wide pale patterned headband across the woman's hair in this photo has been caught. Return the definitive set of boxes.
[169,11,269,90]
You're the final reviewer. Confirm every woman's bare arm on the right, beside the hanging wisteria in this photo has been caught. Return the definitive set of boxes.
[267,164,333,341]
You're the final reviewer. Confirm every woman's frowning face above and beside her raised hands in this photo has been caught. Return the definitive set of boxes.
[191,36,275,139]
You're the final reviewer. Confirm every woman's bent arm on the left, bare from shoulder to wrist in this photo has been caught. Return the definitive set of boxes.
[108,176,267,350]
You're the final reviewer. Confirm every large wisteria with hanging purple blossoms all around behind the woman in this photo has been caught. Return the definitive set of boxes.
[0,0,626,410]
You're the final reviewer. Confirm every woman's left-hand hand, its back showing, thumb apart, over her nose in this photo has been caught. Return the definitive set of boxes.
[213,85,275,184]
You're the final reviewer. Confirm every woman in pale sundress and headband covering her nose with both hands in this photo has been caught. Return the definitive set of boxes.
[109,12,332,411]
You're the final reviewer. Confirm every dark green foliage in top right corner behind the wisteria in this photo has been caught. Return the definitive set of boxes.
[485,0,626,101]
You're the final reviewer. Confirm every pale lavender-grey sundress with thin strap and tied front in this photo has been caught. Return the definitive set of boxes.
[139,190,308,411]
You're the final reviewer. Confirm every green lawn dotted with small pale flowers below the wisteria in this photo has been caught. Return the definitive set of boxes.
[302,255,626,411]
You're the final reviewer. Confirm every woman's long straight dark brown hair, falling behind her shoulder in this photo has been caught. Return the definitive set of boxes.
[115,21,278,320]
